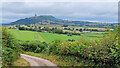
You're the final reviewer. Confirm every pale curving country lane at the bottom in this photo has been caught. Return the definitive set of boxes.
[20,54,58,68]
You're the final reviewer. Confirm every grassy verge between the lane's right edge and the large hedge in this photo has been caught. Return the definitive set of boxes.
[24,52,93,66]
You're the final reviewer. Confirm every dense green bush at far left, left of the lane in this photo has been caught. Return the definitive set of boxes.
[2,27,20,66]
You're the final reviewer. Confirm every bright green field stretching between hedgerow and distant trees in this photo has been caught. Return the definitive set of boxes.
[9,29,102,43]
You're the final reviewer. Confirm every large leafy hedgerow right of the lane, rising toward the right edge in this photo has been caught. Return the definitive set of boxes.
[49,25,120,66]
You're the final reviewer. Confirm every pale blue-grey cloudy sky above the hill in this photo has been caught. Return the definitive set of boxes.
[2,1,118,23]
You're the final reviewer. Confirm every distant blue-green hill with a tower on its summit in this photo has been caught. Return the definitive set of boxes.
[10,16,92,26]
